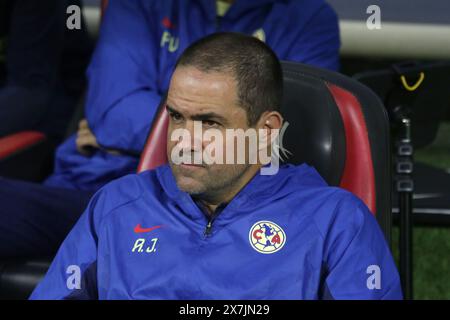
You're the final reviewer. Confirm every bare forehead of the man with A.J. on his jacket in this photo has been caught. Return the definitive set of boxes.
[167,66,237,111]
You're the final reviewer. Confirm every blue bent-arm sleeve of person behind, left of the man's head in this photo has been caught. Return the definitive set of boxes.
[86,0,162,153]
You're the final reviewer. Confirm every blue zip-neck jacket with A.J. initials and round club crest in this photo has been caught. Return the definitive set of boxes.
[31,165,402,299]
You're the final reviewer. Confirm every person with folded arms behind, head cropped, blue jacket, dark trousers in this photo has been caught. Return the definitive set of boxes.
[0,0,339,258]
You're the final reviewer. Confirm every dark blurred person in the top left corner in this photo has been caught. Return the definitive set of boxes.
[0,0,93,142]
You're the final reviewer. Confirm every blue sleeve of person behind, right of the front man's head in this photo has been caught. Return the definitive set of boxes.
[284,2,340,71]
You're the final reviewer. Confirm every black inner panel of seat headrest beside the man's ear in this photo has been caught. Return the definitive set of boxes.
[281,64,345,185]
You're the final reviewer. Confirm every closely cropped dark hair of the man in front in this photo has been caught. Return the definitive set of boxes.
[176,32,283,125]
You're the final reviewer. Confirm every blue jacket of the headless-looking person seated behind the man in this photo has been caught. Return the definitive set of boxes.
[46,0,340,190]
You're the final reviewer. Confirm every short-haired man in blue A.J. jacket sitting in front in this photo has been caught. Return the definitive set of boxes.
[31,33,401,299]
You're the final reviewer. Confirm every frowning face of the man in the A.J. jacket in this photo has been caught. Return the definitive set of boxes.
[167,66,251,197]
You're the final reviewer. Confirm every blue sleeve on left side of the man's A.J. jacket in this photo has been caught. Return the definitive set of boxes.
[30,191,101,300]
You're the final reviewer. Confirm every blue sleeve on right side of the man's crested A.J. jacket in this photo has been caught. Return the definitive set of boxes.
[321,196,402,300]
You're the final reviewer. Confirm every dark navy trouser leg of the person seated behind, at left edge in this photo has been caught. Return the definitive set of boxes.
[0,177,93,259]
